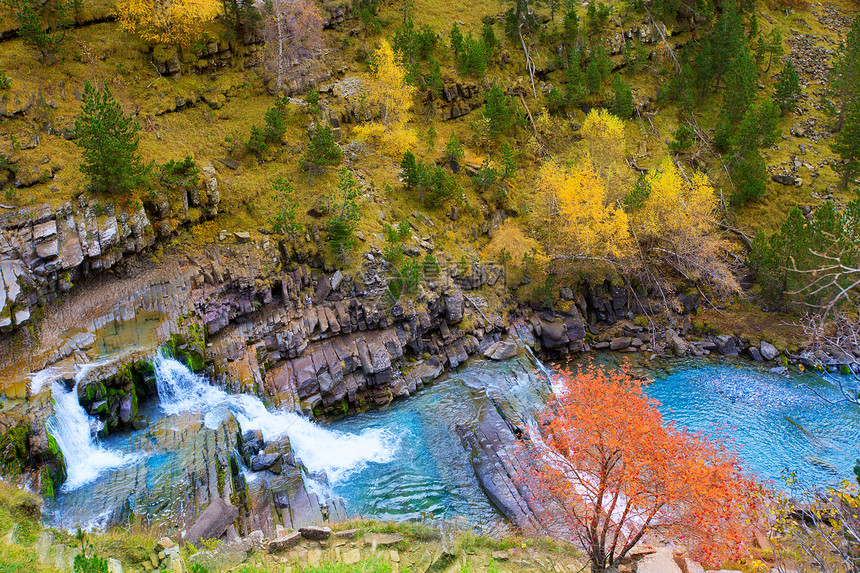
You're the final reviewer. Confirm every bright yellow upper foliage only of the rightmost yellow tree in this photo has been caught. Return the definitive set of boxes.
[639,161,718,238]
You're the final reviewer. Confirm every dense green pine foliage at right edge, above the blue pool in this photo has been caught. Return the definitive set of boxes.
[747,199,860,305]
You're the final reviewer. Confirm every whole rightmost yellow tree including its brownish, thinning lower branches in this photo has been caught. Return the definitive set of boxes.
[633,161,740,295]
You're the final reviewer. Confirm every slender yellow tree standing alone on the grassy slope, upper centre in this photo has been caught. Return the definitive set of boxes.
[355,40,418,156]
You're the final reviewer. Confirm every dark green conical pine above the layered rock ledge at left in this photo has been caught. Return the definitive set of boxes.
[75,82,143,195]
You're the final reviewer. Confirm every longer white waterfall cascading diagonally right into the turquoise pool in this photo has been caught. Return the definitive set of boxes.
[154,355,399,485]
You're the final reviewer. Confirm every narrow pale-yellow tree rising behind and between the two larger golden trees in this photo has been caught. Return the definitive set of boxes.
[582,109,633,202]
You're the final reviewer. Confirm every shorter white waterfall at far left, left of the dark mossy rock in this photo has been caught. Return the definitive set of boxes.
[46,376,136,492]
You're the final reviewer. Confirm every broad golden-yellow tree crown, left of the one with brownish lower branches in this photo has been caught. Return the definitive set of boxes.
[538,161,633,258]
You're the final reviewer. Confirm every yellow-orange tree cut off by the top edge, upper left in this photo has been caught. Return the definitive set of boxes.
[116,0,221,47]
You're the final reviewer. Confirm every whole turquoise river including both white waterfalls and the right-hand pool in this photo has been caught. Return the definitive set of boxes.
[38,348,860,531]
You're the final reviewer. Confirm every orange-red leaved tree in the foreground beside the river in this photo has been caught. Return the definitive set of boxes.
[528,366,761,572]
